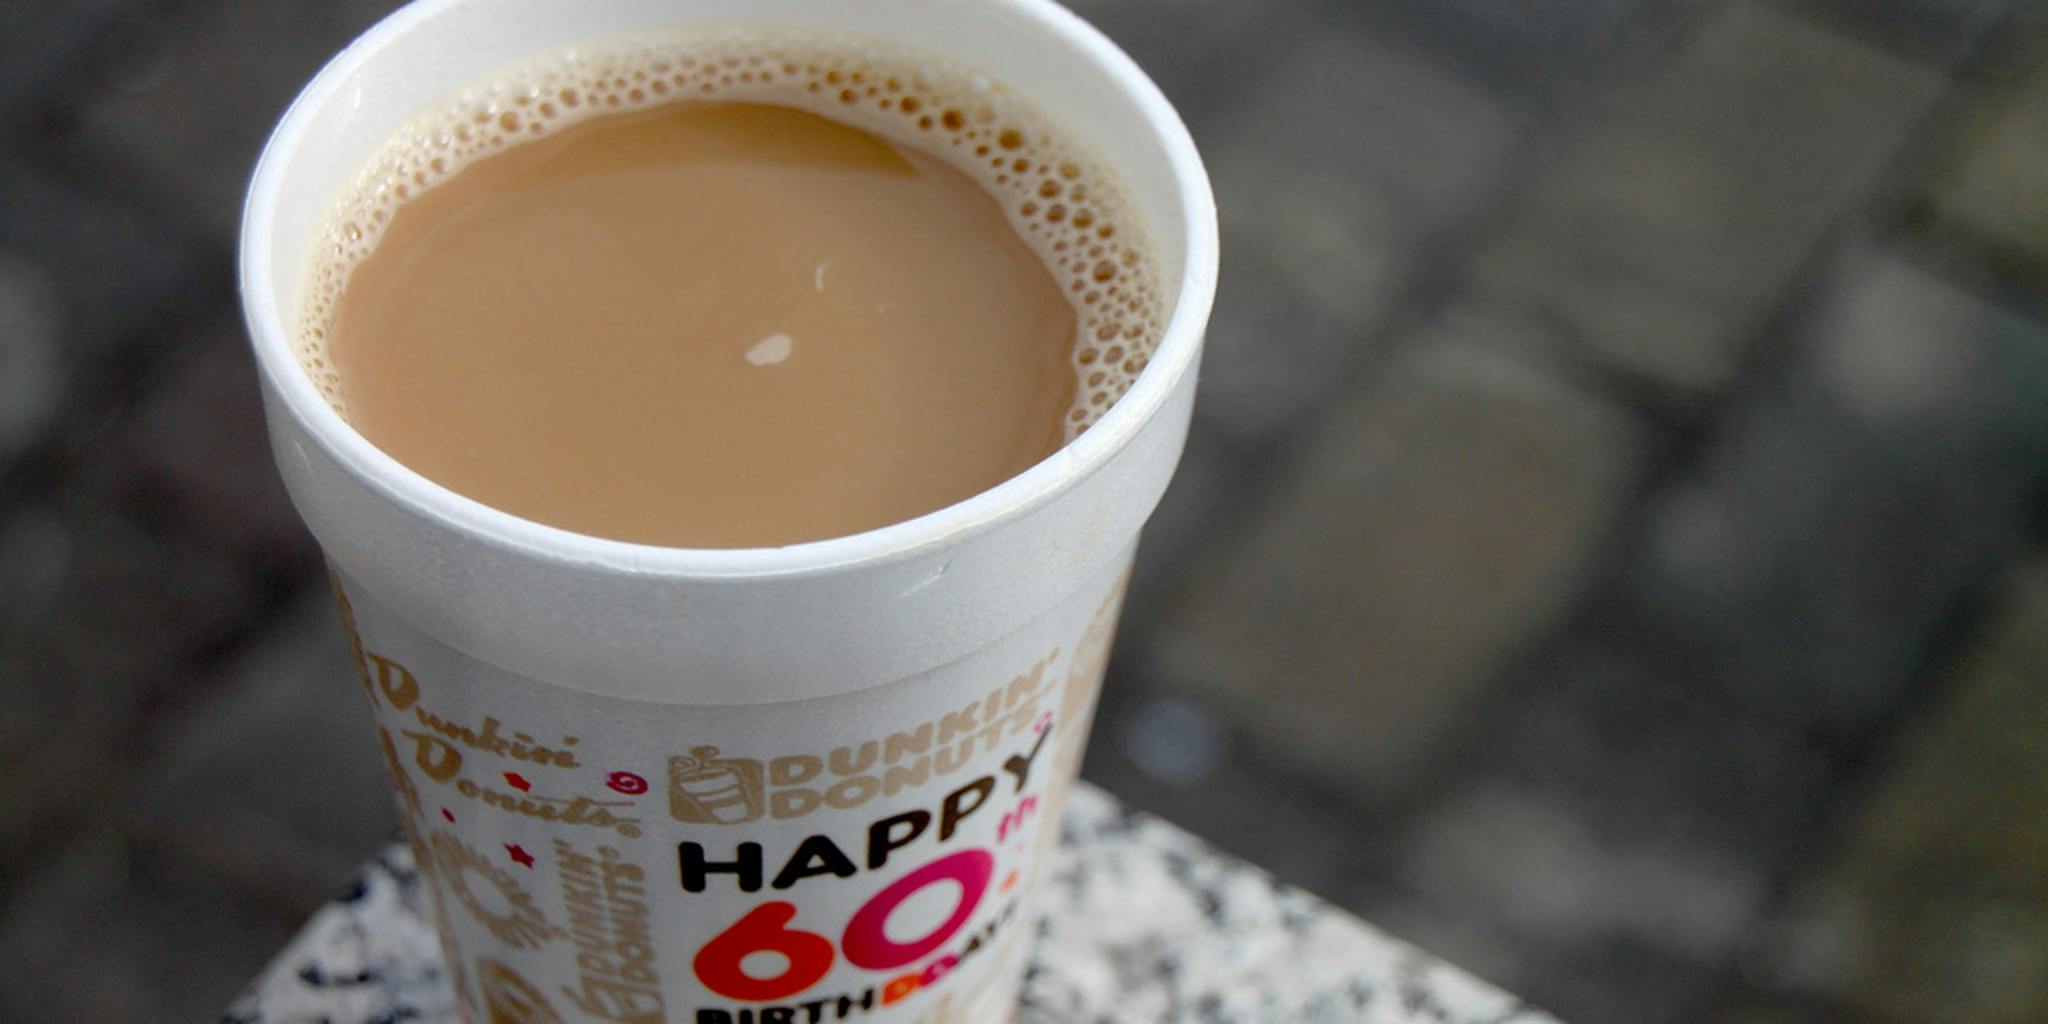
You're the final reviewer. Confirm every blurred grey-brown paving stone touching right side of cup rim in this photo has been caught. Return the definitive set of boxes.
[1202,31,1516,444]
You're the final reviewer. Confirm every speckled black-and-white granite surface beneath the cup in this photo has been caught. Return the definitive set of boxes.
[225,784,1556,1024]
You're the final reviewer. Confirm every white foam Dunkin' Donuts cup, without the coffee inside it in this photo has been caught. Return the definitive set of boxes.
[240,0,1217,1024]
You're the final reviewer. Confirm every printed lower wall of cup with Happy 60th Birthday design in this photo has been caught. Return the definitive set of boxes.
[344,569,1116,1024]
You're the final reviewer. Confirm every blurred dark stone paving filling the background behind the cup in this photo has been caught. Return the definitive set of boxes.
[0,0,2048,1024]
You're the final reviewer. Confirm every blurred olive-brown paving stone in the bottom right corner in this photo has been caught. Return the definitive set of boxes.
[1745,559,2048,1024]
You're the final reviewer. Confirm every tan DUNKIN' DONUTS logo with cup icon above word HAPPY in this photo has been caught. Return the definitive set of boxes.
[668,647,1059,825]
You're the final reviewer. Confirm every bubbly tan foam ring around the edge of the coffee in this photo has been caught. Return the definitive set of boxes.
[297,29,1165,440]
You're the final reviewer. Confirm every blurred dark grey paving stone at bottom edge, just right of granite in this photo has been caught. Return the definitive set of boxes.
[1362,610,1835,1024]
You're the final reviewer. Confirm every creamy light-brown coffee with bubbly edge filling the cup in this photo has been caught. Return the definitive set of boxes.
[299,31,1161,547]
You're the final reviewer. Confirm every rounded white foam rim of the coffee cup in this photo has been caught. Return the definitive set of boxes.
[238,0,1219,580]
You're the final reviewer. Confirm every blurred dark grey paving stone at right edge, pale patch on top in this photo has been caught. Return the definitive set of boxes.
[1628,246,2048,737]
